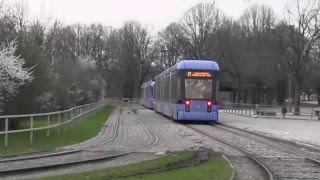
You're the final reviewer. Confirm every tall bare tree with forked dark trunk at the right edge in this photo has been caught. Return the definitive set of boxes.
[275,0,320,114]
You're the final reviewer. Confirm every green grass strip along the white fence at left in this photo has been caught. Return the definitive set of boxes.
[0,105,115,155]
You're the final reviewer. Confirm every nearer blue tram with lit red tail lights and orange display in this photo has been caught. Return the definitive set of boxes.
[154,60,219,121]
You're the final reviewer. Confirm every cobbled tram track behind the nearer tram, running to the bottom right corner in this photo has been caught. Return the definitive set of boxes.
[187,125,320,179]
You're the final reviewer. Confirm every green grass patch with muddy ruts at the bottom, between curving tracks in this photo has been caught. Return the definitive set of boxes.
[42,151,232,180]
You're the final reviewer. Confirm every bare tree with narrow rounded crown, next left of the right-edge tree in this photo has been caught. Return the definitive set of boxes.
[239,5,284,103]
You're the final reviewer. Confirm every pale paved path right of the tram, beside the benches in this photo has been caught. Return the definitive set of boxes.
[219,111,320,147]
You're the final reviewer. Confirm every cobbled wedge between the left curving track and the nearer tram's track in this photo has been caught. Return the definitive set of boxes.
[137,107,238,155]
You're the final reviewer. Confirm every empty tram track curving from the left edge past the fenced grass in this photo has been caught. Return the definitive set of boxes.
[0,108,158,176]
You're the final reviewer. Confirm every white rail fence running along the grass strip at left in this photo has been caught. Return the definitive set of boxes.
[0,100,107,147]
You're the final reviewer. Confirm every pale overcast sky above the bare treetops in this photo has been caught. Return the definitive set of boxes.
[4,0,287,32]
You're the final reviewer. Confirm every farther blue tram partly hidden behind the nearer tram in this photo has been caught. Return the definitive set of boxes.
[140,81,154,109]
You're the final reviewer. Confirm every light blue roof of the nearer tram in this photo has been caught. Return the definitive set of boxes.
[157,60,220,76]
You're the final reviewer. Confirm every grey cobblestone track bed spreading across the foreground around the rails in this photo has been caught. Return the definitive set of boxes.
[0,105,300,179]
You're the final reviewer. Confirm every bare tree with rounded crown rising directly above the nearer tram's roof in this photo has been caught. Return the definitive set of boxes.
[176,4,222,59]
